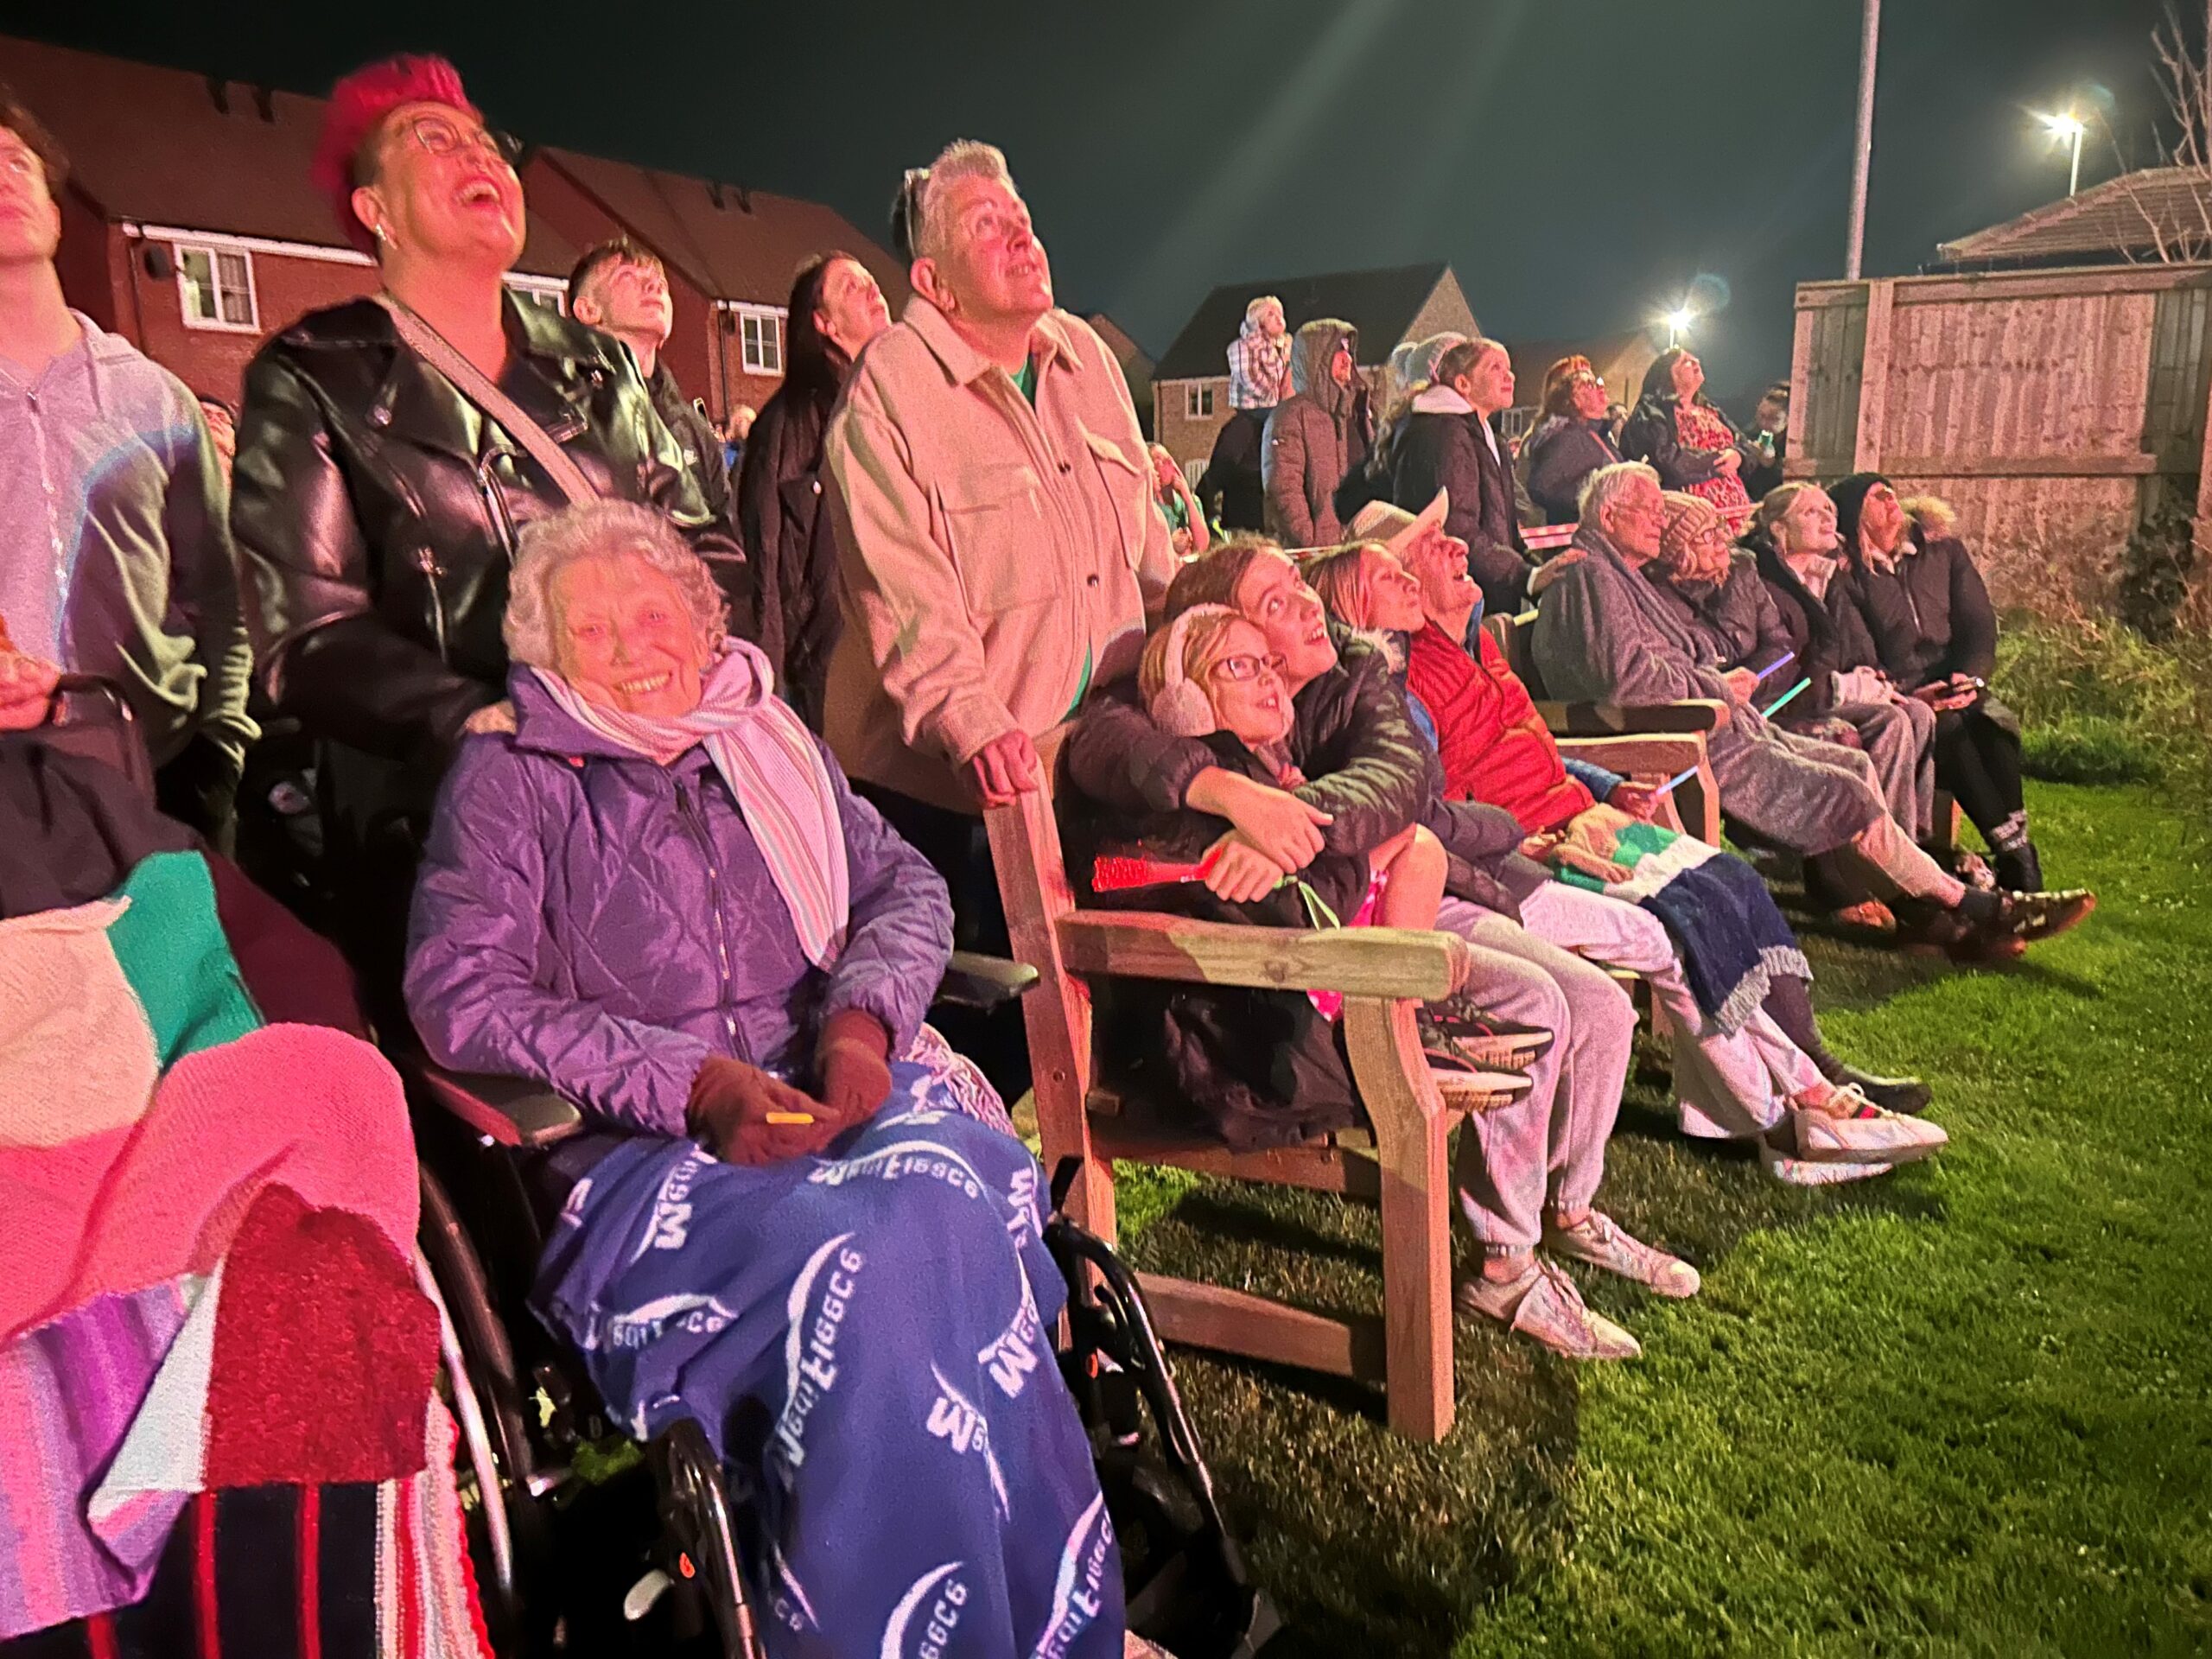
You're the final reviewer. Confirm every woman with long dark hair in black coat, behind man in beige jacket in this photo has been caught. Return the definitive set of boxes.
[736,252,892,732]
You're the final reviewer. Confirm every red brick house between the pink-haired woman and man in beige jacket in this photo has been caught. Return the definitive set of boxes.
[522,149,907,420]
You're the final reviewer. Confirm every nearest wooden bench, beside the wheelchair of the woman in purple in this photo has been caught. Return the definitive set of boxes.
[984,728,1465,1440]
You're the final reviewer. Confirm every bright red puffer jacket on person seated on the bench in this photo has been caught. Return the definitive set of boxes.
[1407,621,1591,834]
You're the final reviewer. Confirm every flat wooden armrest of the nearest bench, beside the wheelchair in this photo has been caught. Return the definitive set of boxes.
[1058,909,1465,1002]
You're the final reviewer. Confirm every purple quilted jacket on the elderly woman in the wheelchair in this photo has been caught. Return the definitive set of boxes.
[407,668,953,1135]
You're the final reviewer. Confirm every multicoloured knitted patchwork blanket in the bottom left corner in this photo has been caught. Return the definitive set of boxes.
[0,852,448,1652]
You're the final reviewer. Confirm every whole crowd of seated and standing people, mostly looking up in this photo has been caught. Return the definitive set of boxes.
[0,58,2094,1655]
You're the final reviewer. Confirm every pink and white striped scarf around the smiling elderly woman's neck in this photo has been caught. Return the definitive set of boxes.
[536,639,852,967]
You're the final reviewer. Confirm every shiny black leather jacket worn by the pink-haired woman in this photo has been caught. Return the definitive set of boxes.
[230,294,743,774]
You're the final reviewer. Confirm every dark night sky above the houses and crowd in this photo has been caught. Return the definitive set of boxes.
[0,0,2196,413]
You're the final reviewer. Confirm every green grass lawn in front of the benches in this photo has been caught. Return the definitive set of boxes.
[1123,785,2212,1659]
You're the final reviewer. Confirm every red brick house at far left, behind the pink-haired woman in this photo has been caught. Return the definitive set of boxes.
[0,35,577,403]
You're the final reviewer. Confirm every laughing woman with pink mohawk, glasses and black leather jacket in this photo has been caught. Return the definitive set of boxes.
[230,58,741,1015]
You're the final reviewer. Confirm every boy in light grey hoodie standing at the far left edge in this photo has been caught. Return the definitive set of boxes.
[0,88,257,841]
